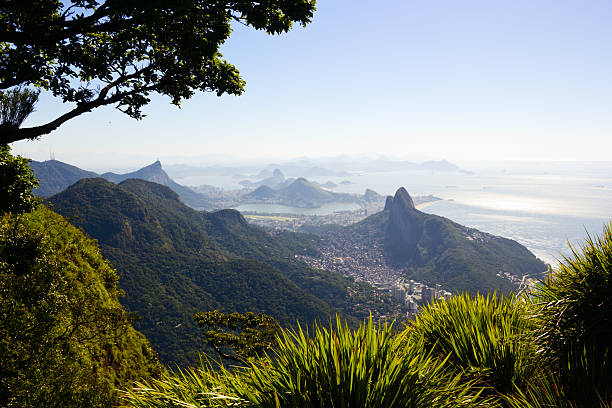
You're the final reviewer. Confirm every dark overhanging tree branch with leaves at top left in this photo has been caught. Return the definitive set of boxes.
[0,0,315,144]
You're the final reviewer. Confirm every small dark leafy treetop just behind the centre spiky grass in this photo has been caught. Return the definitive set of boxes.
[193,310,280,366]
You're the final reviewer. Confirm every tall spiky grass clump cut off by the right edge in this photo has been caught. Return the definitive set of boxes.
[531,225,612,406]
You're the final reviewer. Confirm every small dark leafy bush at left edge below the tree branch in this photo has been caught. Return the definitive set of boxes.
[0,144,38,214]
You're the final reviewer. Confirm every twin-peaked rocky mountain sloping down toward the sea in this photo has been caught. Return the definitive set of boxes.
[311,188,547,293]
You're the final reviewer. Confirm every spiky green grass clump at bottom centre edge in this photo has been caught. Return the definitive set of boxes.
[228,318,471,408]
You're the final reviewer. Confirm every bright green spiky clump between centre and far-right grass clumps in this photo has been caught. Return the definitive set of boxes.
[406,294,535,402]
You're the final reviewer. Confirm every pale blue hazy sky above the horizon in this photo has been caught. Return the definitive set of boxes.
[13,0,612,168]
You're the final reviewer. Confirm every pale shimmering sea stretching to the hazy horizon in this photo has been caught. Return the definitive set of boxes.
[172,162,612,265]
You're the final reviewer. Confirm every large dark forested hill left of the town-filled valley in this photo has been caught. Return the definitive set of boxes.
[49,178,402,364]
